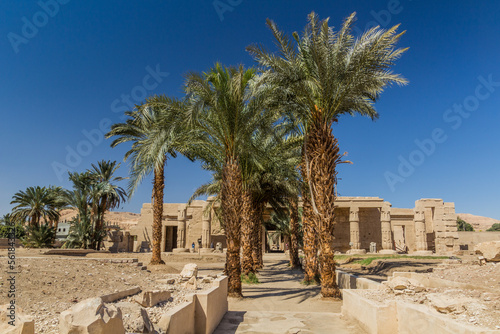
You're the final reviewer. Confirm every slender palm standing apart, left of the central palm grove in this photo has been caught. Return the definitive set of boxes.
[106,95,190,264]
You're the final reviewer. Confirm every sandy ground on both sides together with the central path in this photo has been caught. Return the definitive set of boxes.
[0,249,500,334]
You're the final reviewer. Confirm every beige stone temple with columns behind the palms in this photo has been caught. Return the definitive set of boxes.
[130,197,459,255]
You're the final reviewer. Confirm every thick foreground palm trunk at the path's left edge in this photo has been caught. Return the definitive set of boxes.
[221,157,243,297]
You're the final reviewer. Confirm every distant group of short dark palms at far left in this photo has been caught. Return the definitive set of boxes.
[9,160,126,250]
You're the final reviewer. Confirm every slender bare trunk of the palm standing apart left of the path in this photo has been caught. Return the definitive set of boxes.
[149,160,165,265]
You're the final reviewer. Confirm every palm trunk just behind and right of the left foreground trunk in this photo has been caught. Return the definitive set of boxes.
[241,190,255,276]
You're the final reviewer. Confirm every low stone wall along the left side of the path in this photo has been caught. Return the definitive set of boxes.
[158,276,228,334]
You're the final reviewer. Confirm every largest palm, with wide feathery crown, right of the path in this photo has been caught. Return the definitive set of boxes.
[248,12,406,298]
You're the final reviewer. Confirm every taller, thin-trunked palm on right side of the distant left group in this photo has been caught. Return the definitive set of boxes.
[89,160,127,250]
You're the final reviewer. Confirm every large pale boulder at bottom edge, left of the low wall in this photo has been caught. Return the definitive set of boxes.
[59,298,125,334]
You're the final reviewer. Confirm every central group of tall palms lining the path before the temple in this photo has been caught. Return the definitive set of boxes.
[107,13,406,297]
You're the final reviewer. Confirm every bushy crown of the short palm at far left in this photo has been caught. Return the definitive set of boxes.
[10,186,59,227]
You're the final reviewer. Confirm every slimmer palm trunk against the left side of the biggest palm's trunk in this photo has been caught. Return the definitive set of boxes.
[301,152,318,282]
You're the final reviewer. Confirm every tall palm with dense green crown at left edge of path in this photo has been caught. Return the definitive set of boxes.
[186,64,274,297]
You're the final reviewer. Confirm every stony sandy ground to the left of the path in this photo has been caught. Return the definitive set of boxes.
[0,249,224,333]
